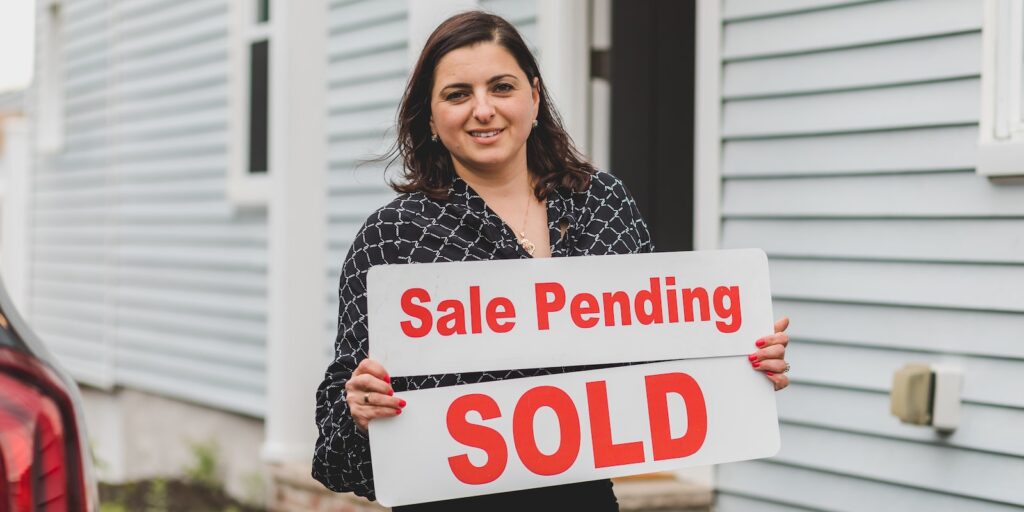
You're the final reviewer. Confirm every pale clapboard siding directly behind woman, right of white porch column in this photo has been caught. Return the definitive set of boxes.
[325,0,537,347]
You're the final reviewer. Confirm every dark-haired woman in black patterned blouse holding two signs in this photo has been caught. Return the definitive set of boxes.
[313,12,788,511]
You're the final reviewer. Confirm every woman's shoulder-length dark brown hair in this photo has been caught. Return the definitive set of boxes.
[382,11,594,199]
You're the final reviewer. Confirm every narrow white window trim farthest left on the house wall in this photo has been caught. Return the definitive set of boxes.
[35,0,65,154]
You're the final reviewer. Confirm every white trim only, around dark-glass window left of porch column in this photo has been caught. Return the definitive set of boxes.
[226,0,280,208]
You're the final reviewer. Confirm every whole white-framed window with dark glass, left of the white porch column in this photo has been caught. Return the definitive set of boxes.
[227,0,273,207]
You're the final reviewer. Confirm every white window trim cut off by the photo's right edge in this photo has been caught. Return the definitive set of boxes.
[977,0,1024,177]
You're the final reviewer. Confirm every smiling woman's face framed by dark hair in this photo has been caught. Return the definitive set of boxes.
[430,43,541,178]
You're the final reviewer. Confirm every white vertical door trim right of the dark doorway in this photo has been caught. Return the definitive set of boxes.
[693,0,722,251]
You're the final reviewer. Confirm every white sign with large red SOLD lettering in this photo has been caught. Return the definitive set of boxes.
[370,356,779,507]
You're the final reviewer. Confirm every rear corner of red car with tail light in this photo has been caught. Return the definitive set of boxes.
[0,282,98,512]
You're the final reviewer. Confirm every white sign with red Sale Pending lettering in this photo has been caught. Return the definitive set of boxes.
[368,249,772,376]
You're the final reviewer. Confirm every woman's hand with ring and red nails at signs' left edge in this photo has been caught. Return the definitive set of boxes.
[345,357,406,431]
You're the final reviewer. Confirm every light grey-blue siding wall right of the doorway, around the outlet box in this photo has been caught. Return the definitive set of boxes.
[717,0,1024,511]
